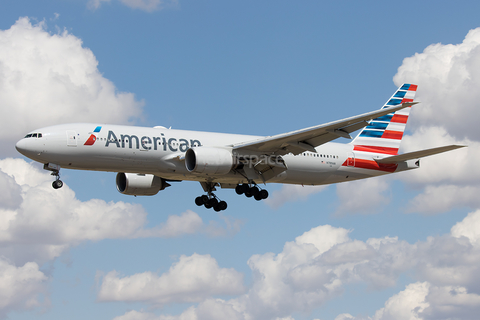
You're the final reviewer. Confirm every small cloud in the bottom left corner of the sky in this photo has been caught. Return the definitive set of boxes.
[0,257,48,318]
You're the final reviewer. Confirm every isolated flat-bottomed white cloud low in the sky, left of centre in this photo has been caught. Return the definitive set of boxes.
[98,254,244,305]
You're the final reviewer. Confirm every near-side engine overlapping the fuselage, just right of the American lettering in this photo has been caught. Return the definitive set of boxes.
[185,147,235,175]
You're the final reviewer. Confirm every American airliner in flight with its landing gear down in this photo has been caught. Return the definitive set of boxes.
[15,84,464,212]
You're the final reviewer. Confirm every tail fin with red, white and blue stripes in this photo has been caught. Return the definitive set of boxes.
[351,84,417,155]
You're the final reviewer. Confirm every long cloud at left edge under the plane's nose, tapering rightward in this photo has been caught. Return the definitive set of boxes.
[0,158,238,263]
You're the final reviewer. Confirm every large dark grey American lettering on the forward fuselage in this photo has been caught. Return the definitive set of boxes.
[104,127,202,152]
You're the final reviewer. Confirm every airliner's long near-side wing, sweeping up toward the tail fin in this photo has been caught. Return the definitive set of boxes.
[232,102,418,155]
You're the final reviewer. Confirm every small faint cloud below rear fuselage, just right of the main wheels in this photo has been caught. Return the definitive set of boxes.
[265,184,328,209]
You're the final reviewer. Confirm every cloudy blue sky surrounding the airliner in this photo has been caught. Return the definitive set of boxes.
[0,0,480,320]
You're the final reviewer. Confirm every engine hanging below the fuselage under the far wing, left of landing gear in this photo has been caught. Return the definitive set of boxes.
[117,172,169,196]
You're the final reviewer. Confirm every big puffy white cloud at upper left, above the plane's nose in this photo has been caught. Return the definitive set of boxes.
[0,17,143,156]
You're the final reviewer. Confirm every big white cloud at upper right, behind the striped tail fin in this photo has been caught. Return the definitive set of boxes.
[394,28,480,140]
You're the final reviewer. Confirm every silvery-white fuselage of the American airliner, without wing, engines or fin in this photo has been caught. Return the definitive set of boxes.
[16,123,407,185]
